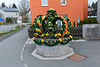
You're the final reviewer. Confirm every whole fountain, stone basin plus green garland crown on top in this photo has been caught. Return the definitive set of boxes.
[32,8,74,60]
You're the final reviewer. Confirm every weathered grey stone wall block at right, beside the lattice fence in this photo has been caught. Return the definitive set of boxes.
[83,24,100,40]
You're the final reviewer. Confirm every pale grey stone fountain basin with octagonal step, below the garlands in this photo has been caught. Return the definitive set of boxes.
[32,44,75,60]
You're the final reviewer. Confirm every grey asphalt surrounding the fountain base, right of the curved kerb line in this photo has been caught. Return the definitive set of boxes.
[23,41,100,67]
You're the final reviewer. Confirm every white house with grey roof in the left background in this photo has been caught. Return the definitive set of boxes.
[0,7,19,19]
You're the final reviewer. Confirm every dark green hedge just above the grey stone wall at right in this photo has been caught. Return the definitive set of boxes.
[77,17,98,26]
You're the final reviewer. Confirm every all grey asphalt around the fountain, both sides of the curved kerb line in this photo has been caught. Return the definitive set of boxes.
[0,28,100,67]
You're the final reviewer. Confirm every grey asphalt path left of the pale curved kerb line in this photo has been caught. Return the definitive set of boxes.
[0,28,28,67]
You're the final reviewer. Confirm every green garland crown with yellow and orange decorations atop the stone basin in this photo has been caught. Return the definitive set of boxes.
[33,8,72,46]
